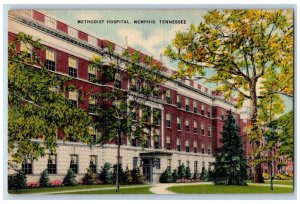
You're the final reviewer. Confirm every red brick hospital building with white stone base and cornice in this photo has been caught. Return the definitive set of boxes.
[8,10,292,182]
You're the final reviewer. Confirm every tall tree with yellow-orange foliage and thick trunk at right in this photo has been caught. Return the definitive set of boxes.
[164,9,293,182]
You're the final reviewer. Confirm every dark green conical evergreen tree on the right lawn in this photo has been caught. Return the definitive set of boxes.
[213,111,247,185]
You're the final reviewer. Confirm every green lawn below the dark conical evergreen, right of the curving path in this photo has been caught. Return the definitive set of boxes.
[168,184,293,194]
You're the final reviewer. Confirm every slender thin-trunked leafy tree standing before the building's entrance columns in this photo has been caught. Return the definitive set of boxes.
[90,46,163,191]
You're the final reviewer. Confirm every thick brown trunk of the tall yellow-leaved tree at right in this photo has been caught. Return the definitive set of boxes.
[250,80,264,183]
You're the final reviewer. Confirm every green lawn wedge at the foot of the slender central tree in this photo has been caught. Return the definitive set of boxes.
[64,186,152,195]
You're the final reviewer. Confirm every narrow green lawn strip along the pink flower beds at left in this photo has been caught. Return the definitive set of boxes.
[8,184,114,194]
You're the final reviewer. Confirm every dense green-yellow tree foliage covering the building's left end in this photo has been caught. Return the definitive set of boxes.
[8,33,91,166]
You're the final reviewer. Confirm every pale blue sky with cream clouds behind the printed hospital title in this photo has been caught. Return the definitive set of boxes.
[41,9,293,112]
